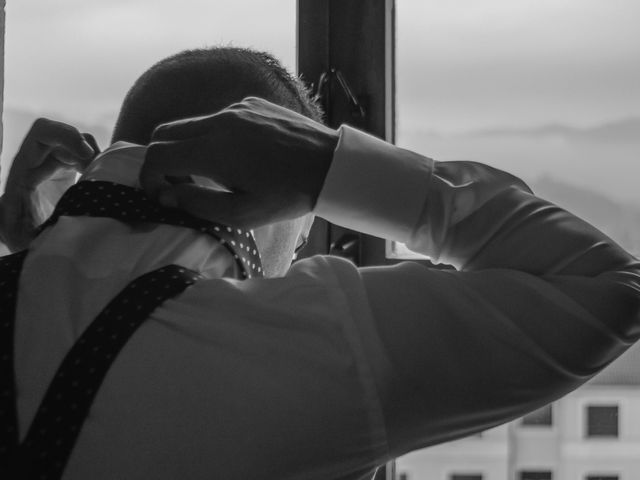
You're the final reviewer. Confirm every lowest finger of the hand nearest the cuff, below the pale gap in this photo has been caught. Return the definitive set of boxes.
[157,184,264,228]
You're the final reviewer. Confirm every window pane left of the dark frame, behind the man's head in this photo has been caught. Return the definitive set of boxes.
[1,0,296,191]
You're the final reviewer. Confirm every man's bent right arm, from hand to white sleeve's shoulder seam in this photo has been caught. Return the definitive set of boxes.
[140,98,640,457]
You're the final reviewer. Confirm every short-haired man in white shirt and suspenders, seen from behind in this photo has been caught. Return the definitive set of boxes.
[1,46,640,479]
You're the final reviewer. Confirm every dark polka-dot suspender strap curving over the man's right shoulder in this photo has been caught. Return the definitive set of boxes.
[7,265,201,480]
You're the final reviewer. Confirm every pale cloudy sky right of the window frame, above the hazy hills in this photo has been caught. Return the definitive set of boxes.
[397,0,640,132]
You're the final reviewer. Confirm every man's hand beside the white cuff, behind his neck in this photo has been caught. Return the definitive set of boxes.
[140,97,338,228]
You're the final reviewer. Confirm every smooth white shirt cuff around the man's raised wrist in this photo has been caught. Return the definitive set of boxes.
[314,125,434,242]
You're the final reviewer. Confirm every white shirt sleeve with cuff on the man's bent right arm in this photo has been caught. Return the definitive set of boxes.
[316,123,640,455]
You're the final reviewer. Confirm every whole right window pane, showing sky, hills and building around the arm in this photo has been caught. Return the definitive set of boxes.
[396,0,640,480]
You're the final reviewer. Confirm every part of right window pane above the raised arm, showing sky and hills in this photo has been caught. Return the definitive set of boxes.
[387,0,640,258]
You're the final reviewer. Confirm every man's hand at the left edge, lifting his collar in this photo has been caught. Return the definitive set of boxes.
[0,118,100,251]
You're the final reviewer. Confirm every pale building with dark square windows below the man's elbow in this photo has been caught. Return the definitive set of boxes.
[396,344,640,480]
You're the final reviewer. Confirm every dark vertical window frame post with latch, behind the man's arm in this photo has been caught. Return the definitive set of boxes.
[296,0,398,480]
